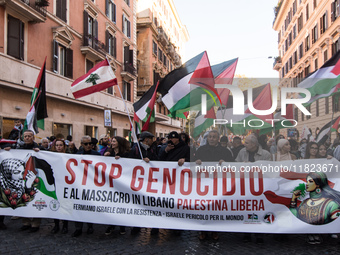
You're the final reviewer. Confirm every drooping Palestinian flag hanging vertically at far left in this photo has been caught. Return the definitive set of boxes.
[24,57,48,134]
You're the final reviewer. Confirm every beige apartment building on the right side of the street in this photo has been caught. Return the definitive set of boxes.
[273,0,340,138]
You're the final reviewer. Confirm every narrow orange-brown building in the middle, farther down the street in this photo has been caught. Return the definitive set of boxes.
[137,0,189,137]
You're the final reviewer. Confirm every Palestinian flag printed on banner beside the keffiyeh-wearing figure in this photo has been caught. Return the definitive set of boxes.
[24,156,57,199]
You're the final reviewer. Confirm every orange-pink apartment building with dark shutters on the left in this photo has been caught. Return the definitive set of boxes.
[0,0,137,144]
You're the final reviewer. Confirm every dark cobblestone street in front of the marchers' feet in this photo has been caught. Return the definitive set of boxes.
[0,217,339,255]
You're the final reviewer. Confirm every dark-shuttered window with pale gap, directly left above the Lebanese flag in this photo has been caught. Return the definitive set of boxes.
[53,41,73,78]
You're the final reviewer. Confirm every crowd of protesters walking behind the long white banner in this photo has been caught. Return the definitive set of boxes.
[0,120,340,243]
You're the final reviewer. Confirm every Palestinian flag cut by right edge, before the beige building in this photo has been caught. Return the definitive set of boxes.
[298,51,340,106]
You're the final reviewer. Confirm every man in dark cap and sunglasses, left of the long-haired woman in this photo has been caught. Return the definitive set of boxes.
[72,135,101,237]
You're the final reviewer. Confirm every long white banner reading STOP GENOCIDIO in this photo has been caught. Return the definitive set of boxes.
[0,150,340,233]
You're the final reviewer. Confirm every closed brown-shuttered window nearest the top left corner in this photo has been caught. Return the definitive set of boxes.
[7,15,25,60]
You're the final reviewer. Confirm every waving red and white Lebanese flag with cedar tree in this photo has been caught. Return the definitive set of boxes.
[71,59,118,99]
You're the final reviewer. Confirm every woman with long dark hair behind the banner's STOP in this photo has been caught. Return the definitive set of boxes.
[104,136,130,236]
